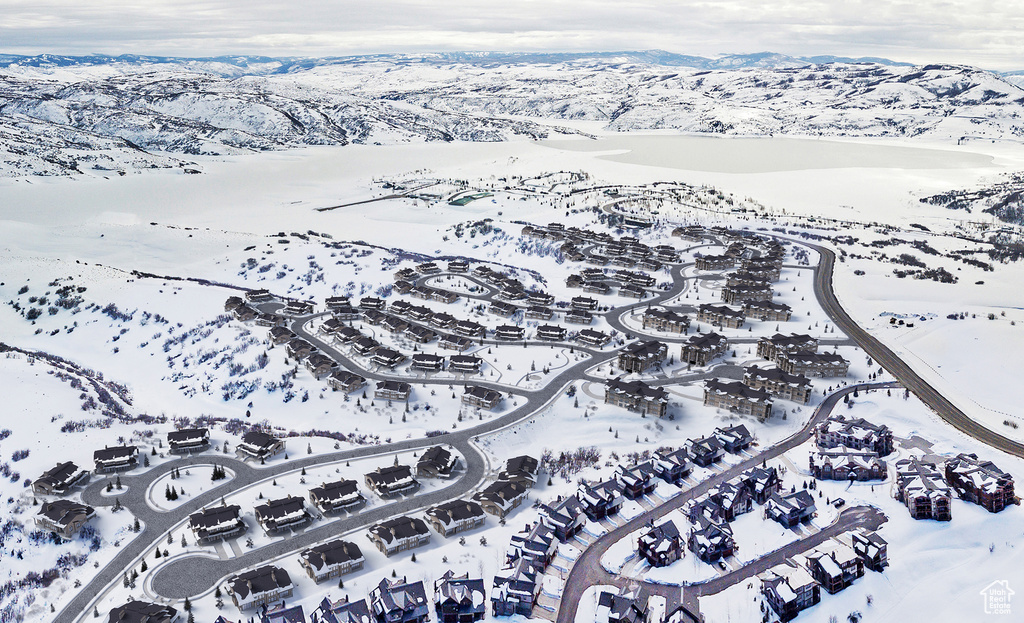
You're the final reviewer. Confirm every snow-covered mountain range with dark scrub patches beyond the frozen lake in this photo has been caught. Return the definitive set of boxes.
[0,50,1024,175]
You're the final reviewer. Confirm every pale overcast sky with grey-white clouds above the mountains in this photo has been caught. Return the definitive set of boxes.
[0,0,1024,70]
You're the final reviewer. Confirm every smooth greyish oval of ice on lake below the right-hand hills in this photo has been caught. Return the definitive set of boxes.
[541,134,992,173]
